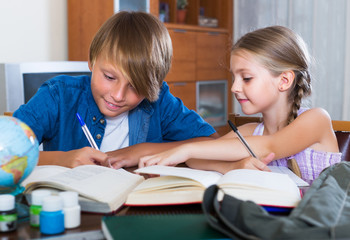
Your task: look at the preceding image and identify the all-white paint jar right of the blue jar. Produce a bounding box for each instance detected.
[59,191,80,229]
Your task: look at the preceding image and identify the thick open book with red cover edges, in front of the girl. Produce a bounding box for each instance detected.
[125,165,307,208]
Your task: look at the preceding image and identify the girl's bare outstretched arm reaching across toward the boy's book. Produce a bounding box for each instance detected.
[139,108,339,167]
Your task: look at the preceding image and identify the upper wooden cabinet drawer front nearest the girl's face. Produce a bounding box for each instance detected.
[196,32,230,81]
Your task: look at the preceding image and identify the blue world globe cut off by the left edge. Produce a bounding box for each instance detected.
[0,116,39,195]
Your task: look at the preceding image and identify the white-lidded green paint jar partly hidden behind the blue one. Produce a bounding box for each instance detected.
[29,189,51,227]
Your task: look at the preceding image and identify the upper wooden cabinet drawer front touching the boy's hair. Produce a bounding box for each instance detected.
[165,29,196,82]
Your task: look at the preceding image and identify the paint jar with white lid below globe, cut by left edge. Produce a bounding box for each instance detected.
[0,194,17,232]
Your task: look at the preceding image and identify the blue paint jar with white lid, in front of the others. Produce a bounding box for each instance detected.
[40,196,64,235]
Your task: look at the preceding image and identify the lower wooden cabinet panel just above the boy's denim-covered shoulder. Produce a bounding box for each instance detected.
[168,82,196,111]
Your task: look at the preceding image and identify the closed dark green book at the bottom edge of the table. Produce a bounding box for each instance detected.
[102,214,229,240]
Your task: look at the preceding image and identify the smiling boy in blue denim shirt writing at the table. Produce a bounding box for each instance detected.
[14,12,218,168]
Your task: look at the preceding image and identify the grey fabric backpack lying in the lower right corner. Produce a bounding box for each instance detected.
[202,162,350,240]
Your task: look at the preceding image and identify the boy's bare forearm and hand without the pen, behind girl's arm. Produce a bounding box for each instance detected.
[107,133,219,169]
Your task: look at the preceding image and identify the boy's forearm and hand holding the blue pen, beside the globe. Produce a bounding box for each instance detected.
[38,147,107,168]
